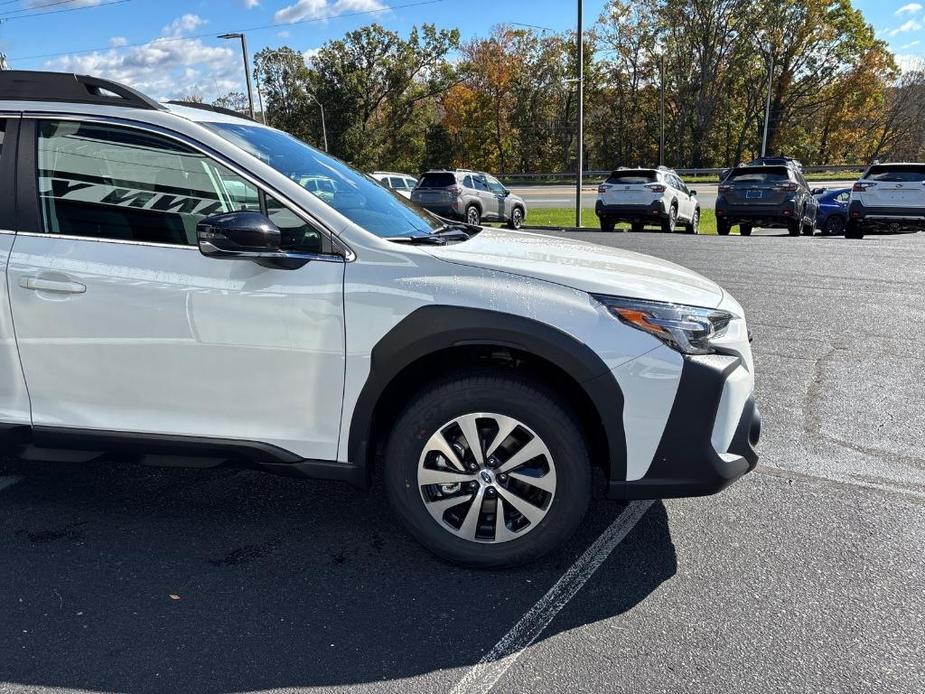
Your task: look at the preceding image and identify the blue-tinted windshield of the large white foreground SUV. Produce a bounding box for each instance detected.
[203,123,443,238]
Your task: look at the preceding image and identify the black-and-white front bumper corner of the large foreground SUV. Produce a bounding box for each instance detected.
[608,355,761,499]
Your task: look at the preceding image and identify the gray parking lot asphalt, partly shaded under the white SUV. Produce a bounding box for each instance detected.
[0,232,925,694]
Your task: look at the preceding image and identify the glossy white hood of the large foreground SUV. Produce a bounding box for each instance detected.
[427,228,723,308]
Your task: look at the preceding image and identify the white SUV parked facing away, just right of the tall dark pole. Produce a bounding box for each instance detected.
[594,166,700,234]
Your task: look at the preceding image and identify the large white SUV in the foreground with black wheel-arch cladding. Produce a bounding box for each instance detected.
[0,72,760,567]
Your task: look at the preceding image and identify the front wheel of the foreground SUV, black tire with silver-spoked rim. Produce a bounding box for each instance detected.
[384,371,591,569]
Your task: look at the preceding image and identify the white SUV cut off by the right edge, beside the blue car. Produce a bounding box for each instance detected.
[845,163,925,239]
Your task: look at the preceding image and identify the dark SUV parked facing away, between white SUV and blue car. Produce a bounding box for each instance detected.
[716,164,819,236]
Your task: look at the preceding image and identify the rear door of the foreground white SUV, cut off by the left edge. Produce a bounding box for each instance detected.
[0,114,31,428]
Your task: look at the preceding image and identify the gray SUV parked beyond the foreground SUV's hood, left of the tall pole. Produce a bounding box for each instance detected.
[411,169,527,229]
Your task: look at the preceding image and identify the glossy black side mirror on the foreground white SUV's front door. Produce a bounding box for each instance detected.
[196,210,308,270]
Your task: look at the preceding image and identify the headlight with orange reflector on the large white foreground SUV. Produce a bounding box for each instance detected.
[591,294,734,354]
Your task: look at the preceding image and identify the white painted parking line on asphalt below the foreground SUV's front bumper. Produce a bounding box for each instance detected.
[451,501,653,694]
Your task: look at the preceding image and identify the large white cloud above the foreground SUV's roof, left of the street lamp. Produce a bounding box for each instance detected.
[45,15,244,100]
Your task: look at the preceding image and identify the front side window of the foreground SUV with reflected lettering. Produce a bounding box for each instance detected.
[38,121,260,245]
